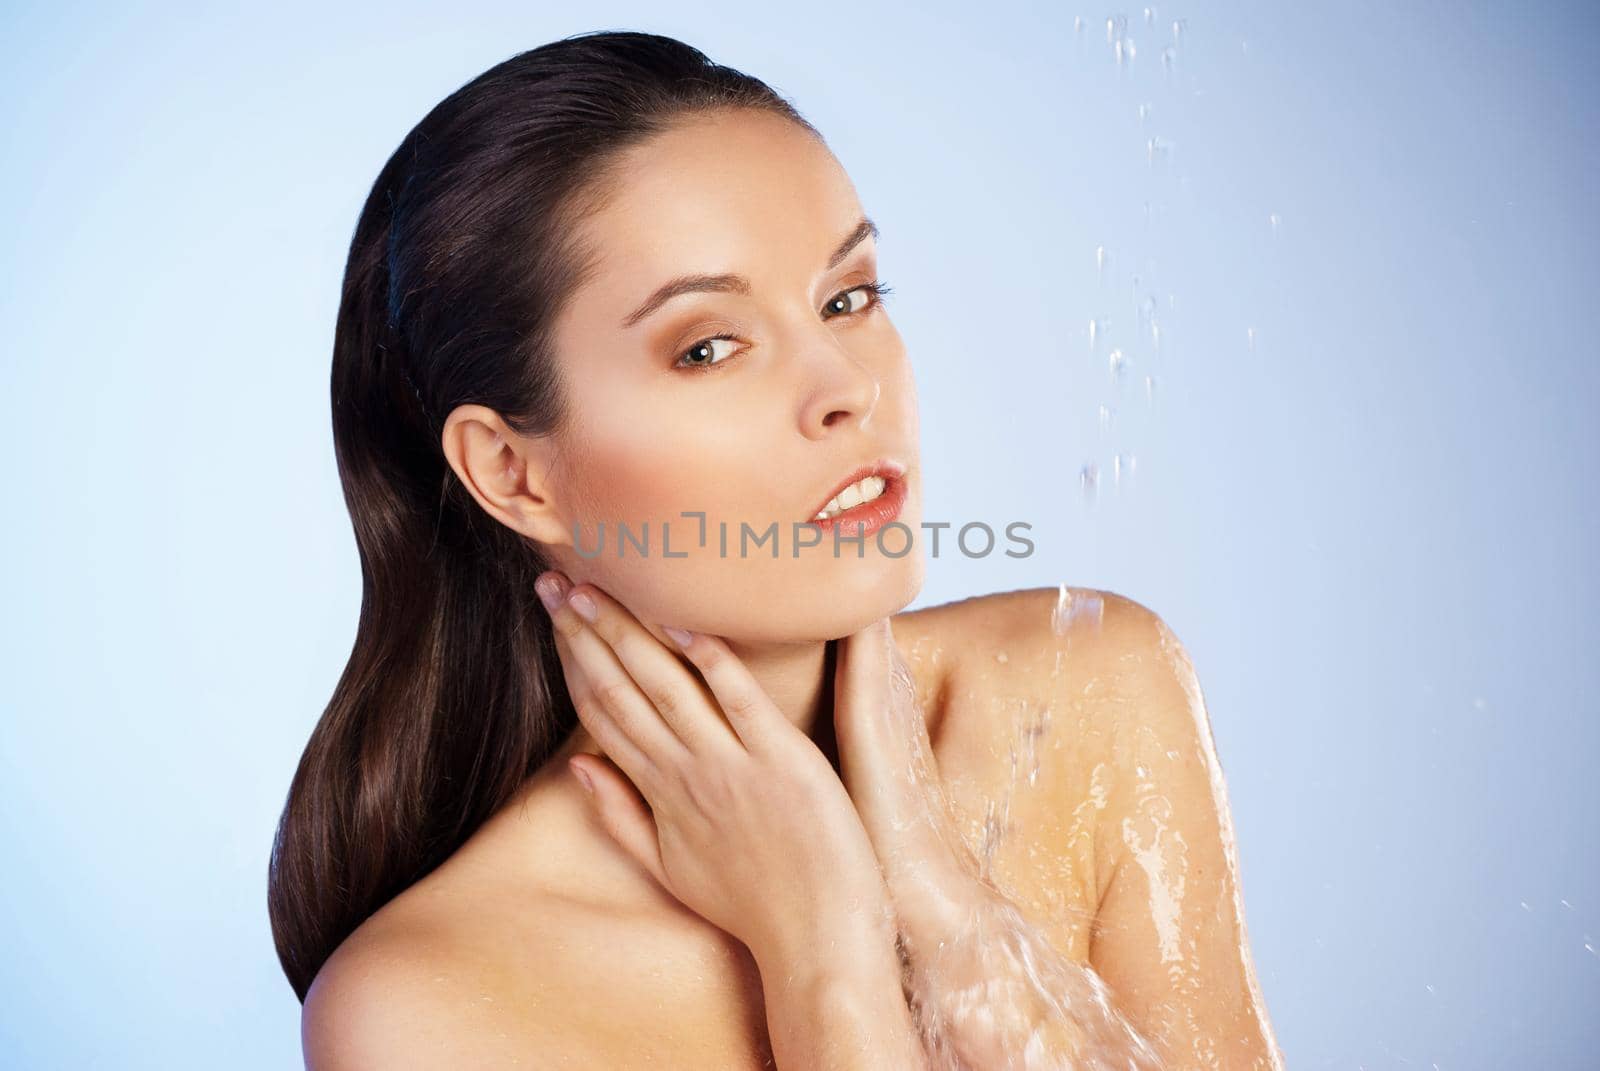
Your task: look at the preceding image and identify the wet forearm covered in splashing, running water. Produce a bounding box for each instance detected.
[899,879,1158,1071]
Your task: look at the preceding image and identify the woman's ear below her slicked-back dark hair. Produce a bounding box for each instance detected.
[440,405,573,544]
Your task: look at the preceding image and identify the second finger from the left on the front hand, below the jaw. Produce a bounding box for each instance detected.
[560,584,739,756]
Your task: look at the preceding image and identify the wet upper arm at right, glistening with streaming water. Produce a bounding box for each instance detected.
[1090,596,1282,1068]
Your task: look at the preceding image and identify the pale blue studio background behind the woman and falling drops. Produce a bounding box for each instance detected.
[0,2,1600,1069]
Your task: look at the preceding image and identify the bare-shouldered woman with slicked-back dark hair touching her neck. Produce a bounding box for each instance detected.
[269,32,1278,1069]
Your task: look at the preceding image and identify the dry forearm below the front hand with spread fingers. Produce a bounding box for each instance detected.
[754,914,928,1071]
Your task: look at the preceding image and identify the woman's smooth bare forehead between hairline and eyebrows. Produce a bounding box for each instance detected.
[582,109,862,296]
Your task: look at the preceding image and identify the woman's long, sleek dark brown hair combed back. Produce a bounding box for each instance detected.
[267,30,819,1001]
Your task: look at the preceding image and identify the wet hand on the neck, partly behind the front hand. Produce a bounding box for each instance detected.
[834,618,990,948]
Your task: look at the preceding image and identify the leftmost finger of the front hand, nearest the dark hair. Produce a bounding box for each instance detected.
[534,575,690,781]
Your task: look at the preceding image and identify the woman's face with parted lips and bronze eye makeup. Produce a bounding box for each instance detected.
[530,110,925,642]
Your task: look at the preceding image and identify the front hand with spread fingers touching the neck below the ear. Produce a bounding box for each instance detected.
[538,572,894,970]
